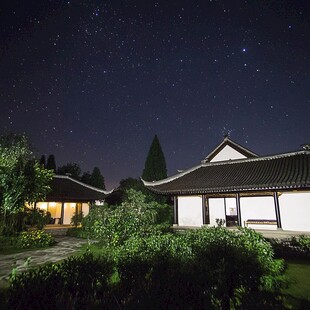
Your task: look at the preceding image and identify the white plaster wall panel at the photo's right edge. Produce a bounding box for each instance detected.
[279,192,310,231]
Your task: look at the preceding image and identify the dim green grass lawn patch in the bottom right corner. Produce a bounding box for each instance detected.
[284,260,310,309]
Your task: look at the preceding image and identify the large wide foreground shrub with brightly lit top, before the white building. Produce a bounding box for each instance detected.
[116,228,283,309]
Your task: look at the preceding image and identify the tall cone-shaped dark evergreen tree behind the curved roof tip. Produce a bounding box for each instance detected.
[142,135,167,181]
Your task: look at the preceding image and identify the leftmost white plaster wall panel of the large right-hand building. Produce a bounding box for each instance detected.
[178,196,203,226]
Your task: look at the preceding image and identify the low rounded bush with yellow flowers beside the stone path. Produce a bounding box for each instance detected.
[16,230,55,249]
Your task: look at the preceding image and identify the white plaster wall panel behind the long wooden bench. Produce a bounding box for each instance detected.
[240,196,277,230]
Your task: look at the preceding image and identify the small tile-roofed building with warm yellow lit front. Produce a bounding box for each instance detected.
[36,175,111,224]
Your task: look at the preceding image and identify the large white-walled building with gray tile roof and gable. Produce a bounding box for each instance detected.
[144,137,310,232]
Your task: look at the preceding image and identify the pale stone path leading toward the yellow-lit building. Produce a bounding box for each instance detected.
[0,236,87,286]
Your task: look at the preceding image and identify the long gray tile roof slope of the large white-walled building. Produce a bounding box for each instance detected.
[144,151,310,194]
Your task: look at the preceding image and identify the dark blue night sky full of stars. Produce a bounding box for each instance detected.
[0,0,310,189]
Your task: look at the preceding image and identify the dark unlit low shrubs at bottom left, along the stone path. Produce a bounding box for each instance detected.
[8,253,115,309]
